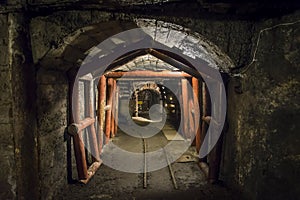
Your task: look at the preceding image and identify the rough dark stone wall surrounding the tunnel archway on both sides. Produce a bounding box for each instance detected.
[0,0,300,199]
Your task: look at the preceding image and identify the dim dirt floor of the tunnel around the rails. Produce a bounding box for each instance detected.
[56,121,240,200]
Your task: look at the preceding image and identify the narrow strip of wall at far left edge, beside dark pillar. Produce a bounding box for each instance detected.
[0,14,16,199]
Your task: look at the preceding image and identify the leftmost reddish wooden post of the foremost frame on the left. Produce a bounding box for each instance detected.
[72,82,88,179]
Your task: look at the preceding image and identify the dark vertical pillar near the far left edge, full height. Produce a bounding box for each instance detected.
[8,13,39,199]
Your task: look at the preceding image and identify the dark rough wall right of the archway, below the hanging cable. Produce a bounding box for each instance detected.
[222,14,300,199]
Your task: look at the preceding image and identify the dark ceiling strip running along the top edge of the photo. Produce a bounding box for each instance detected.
[0,0,300,19]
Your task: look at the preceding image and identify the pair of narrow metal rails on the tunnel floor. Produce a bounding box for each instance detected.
[142,138,178,190]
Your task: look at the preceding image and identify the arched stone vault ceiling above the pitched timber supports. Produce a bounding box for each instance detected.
[40,19,234,79]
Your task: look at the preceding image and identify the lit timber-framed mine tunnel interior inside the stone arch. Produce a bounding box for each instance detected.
[60,46,227,198]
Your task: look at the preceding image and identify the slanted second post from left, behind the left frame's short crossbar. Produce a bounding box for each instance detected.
[88,80,100,162]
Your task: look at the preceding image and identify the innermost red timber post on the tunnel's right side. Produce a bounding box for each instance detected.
[181,79,190,138]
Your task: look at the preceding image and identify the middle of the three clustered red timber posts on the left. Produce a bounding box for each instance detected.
[105,78,114,144]
